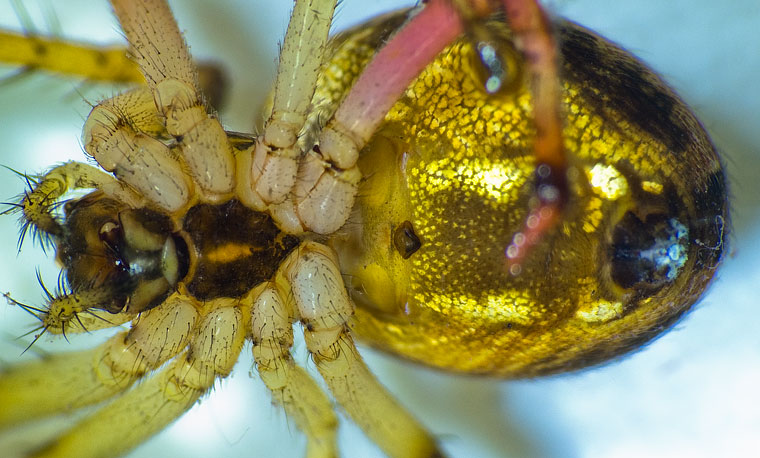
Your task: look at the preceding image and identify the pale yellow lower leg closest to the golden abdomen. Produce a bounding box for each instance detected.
[277,242,440,457]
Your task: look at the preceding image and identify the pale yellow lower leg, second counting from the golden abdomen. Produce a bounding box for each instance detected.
[251,284,338,458]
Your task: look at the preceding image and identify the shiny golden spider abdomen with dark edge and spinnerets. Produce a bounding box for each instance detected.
[324,13,728,377]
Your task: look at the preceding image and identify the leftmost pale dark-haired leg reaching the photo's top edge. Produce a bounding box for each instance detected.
[109,0,235,201]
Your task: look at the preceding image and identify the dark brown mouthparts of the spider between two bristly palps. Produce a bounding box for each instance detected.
[57,193,189,313]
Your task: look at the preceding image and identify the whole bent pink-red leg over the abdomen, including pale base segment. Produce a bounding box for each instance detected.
[295,0,568,268]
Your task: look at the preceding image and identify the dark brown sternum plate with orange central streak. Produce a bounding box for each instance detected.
[183,200,300,300]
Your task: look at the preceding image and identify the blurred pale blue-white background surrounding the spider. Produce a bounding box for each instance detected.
[0,0,760,458]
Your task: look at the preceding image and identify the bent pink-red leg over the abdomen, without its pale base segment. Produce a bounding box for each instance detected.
[320,0,568,275]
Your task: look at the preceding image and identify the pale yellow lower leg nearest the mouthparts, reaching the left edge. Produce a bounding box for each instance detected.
[0,296,198,430]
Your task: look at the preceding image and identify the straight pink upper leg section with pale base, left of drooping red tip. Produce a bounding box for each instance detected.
[285,0,462,234]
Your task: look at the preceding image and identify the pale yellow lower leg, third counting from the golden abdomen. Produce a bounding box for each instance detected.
[26,299,247,458]
